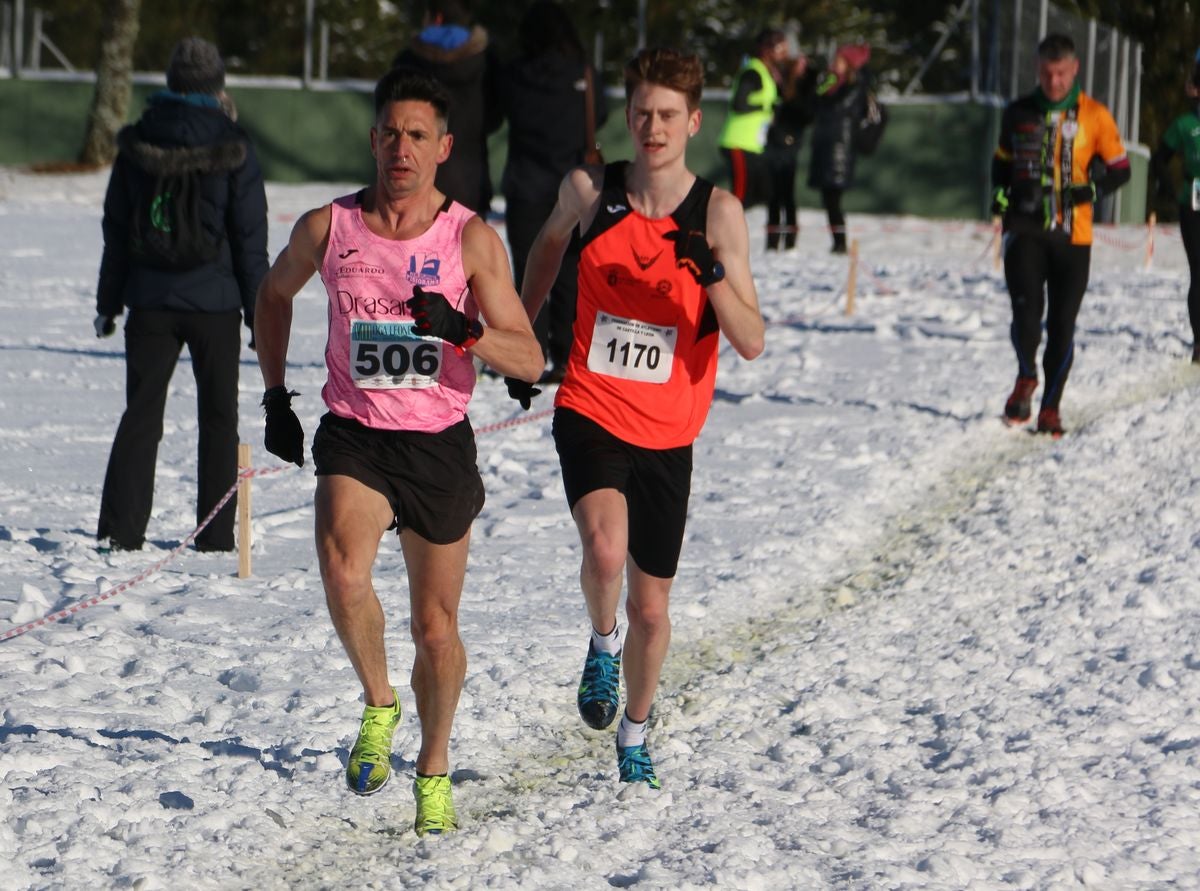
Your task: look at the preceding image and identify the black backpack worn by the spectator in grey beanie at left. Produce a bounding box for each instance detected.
[130,169,224,273]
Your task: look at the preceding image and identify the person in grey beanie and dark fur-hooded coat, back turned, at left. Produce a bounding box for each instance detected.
[95,37,268,550]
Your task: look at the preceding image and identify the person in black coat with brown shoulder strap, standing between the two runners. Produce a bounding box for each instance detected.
[499,0,607,381]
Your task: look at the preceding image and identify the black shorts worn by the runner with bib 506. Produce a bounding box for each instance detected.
[312,412,484,544]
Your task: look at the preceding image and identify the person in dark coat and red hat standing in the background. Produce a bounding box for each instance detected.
[809,43,871,253]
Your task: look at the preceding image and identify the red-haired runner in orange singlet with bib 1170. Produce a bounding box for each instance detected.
[509,49,763,789]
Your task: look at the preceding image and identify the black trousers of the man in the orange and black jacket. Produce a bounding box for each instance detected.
[1004,232,1092,408]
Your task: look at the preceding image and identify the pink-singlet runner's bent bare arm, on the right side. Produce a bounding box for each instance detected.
[462,216,545,383]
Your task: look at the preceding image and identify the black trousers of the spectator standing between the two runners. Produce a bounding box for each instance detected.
[504,198,581,369]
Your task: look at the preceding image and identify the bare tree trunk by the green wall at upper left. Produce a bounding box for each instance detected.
[79,0,142,166]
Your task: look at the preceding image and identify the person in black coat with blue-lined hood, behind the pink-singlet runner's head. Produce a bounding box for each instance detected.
[392,0,503,217]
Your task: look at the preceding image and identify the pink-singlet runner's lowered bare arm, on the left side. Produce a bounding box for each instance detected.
[254,211,331,390]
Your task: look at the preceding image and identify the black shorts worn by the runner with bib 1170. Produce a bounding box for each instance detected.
[553,408,691,579]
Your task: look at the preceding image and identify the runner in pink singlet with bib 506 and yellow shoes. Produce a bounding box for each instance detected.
[254,68,542,835]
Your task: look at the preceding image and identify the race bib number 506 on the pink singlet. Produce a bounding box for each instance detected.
[350,319,444,390]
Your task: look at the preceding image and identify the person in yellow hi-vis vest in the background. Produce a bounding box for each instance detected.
[718,29,788,208]
